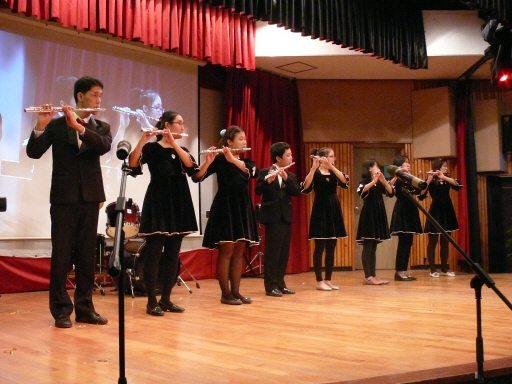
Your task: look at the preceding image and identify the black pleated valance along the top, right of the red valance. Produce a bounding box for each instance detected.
[204,0,427,69]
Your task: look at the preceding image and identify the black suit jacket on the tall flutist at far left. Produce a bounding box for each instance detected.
[27,117,112,204]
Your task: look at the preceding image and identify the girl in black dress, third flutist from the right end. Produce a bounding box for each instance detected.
[356,159,393,285]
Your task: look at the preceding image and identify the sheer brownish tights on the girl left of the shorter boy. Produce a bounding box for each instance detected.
[217,241,246,299]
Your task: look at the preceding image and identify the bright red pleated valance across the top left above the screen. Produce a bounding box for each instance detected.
[0,0,256,70]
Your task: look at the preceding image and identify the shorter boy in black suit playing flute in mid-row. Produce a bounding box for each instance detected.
[255,142,300,297]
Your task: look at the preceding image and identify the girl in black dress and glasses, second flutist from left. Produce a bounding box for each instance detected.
[130,111,214,316]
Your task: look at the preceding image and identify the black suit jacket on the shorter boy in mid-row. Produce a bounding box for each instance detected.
[255,168,300,224]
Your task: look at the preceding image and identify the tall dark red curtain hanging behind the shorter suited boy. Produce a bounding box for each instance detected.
[225,69,310,273]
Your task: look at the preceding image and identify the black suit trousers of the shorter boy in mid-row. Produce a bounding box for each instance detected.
[264,218,292,292]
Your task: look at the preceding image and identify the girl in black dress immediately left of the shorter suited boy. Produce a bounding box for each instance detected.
[198,126,259,305]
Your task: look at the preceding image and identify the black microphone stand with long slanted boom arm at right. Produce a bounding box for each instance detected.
[402,187,512,383]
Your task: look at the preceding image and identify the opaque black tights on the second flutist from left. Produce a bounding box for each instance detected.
[142,235,183,308]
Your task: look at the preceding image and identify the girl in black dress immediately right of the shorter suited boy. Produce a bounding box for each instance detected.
[301,147,349,291]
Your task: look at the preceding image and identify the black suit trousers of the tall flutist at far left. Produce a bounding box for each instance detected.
[50,203,99,318]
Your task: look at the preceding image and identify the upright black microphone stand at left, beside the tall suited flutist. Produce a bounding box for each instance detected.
[109,159,131,384]
